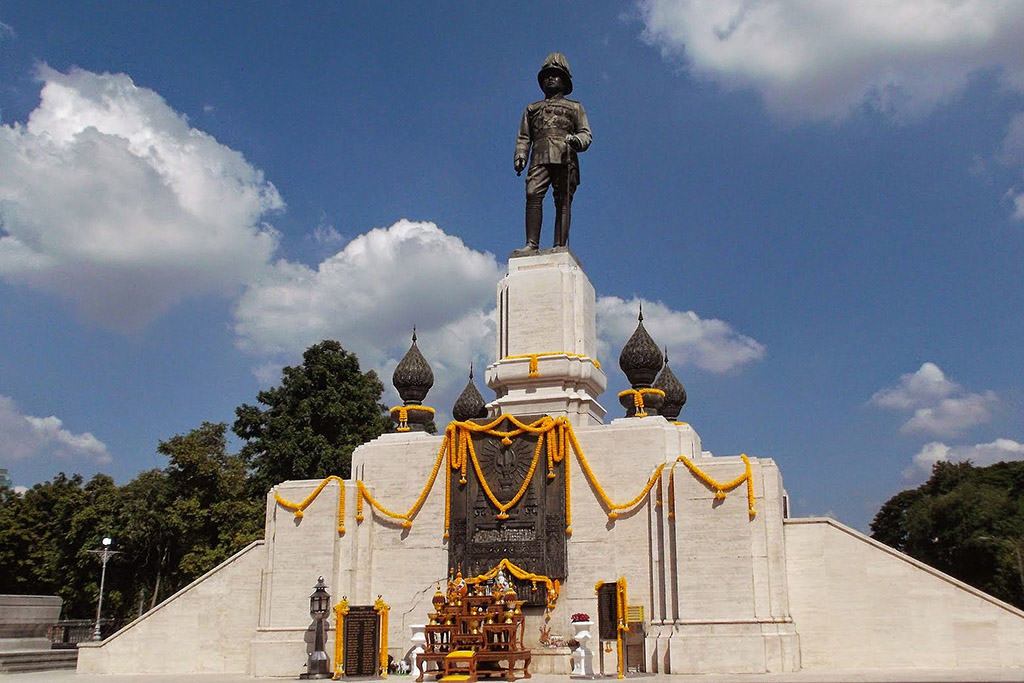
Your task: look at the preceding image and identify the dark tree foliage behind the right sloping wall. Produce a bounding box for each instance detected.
[871,462,1024,607]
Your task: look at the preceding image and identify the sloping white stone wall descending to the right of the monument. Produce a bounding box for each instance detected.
[784,519,1024,671]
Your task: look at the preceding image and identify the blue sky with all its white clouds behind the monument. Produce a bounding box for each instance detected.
[0,0,1024,528]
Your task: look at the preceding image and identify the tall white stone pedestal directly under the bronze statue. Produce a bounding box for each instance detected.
[486,250,608,425]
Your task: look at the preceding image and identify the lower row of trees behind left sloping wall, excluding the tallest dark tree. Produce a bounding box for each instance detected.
[0,423,264,623]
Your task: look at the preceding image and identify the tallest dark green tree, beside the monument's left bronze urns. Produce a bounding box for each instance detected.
[233,340,388,495]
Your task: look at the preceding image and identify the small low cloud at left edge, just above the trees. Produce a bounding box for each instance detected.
[0,395,111,463]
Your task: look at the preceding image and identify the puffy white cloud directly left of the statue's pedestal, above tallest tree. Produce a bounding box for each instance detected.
[234,220,503,417]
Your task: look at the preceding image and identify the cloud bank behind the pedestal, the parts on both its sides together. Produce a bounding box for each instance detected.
[234,220,765,419]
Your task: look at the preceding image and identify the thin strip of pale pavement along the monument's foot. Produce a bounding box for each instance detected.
[0,669,1024,683]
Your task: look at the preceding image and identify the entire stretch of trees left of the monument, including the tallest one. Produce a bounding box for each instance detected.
[0,341,397,624]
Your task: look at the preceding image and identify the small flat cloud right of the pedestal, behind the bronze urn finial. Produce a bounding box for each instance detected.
[597,296,765,373]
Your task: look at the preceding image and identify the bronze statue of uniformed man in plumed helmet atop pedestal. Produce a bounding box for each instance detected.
[513,52,593,254]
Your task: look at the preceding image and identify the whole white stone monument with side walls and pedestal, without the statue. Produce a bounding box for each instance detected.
[79,246,1024,680]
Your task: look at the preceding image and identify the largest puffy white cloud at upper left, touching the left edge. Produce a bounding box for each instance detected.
[0,67,284,330]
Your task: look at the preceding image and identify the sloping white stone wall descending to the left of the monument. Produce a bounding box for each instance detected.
[78,541,266,674]
